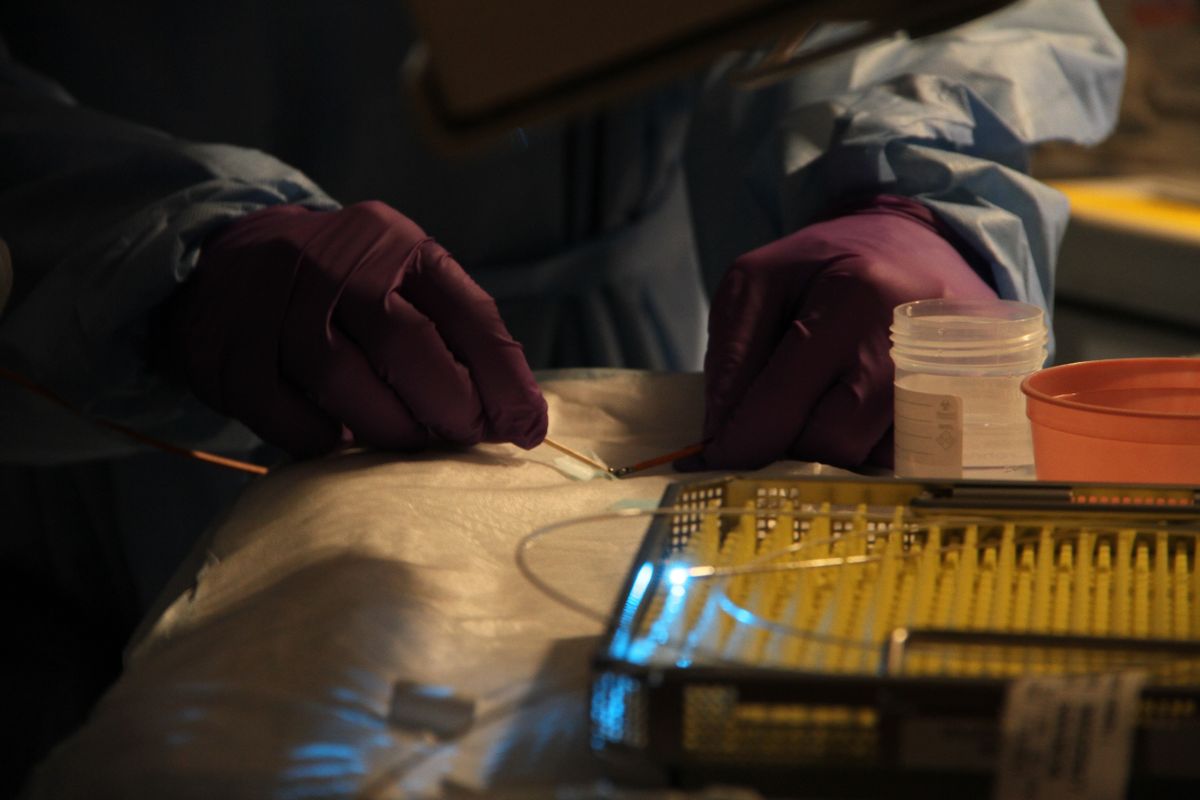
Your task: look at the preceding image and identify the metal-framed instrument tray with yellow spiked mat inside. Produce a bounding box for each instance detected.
[590,477,1200,794]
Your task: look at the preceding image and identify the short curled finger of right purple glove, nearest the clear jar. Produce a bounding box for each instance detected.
[788,381,893,467]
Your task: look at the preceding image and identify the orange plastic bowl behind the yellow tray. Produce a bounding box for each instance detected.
[1021,359,1200,483]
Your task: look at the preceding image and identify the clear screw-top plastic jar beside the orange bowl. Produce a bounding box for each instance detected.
[892,300,1046,479]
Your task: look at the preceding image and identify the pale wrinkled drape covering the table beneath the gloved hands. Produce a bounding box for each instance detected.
[26,371,811,800]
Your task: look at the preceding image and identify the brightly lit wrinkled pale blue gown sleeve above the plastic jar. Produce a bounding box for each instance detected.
[729,0,1124,347]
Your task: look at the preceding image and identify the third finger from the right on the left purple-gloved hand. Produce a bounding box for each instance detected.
[284,326,430,450]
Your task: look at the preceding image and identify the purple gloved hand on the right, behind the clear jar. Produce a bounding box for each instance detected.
[679,196,996,469]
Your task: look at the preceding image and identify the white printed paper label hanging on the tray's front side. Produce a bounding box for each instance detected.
[994,673,1146,800]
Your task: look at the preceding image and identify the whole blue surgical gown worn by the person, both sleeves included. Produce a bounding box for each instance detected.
[0,0,1123,606]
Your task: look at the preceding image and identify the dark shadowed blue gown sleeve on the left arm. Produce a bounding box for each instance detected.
[0,70,335,462]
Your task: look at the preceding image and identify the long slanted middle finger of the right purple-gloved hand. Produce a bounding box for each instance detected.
[703,320,839,469]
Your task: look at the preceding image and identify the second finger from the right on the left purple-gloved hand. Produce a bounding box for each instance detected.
[335,290,484,444]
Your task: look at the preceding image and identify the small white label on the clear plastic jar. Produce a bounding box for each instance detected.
[895,385,962,477]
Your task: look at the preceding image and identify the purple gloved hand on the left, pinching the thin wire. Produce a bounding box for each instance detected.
[167,203,546,456]
